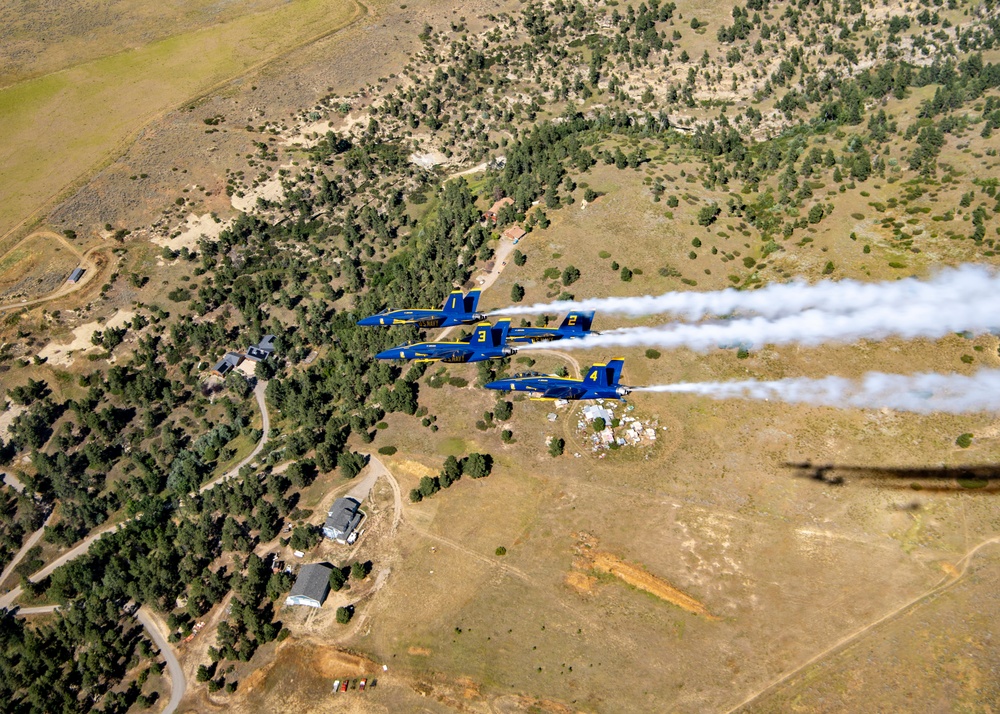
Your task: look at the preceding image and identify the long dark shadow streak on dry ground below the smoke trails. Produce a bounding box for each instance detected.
[783,461,1000,494]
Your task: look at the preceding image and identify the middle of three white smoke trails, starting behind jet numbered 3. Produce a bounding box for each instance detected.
[520,296,1000,351]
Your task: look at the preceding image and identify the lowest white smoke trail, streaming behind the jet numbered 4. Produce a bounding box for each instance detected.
[632,369,1000,414]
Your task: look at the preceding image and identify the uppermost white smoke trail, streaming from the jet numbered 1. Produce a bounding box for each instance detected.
[490,264,1000,320]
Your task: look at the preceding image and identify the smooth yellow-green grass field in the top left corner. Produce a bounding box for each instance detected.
[0,0,365,245]
